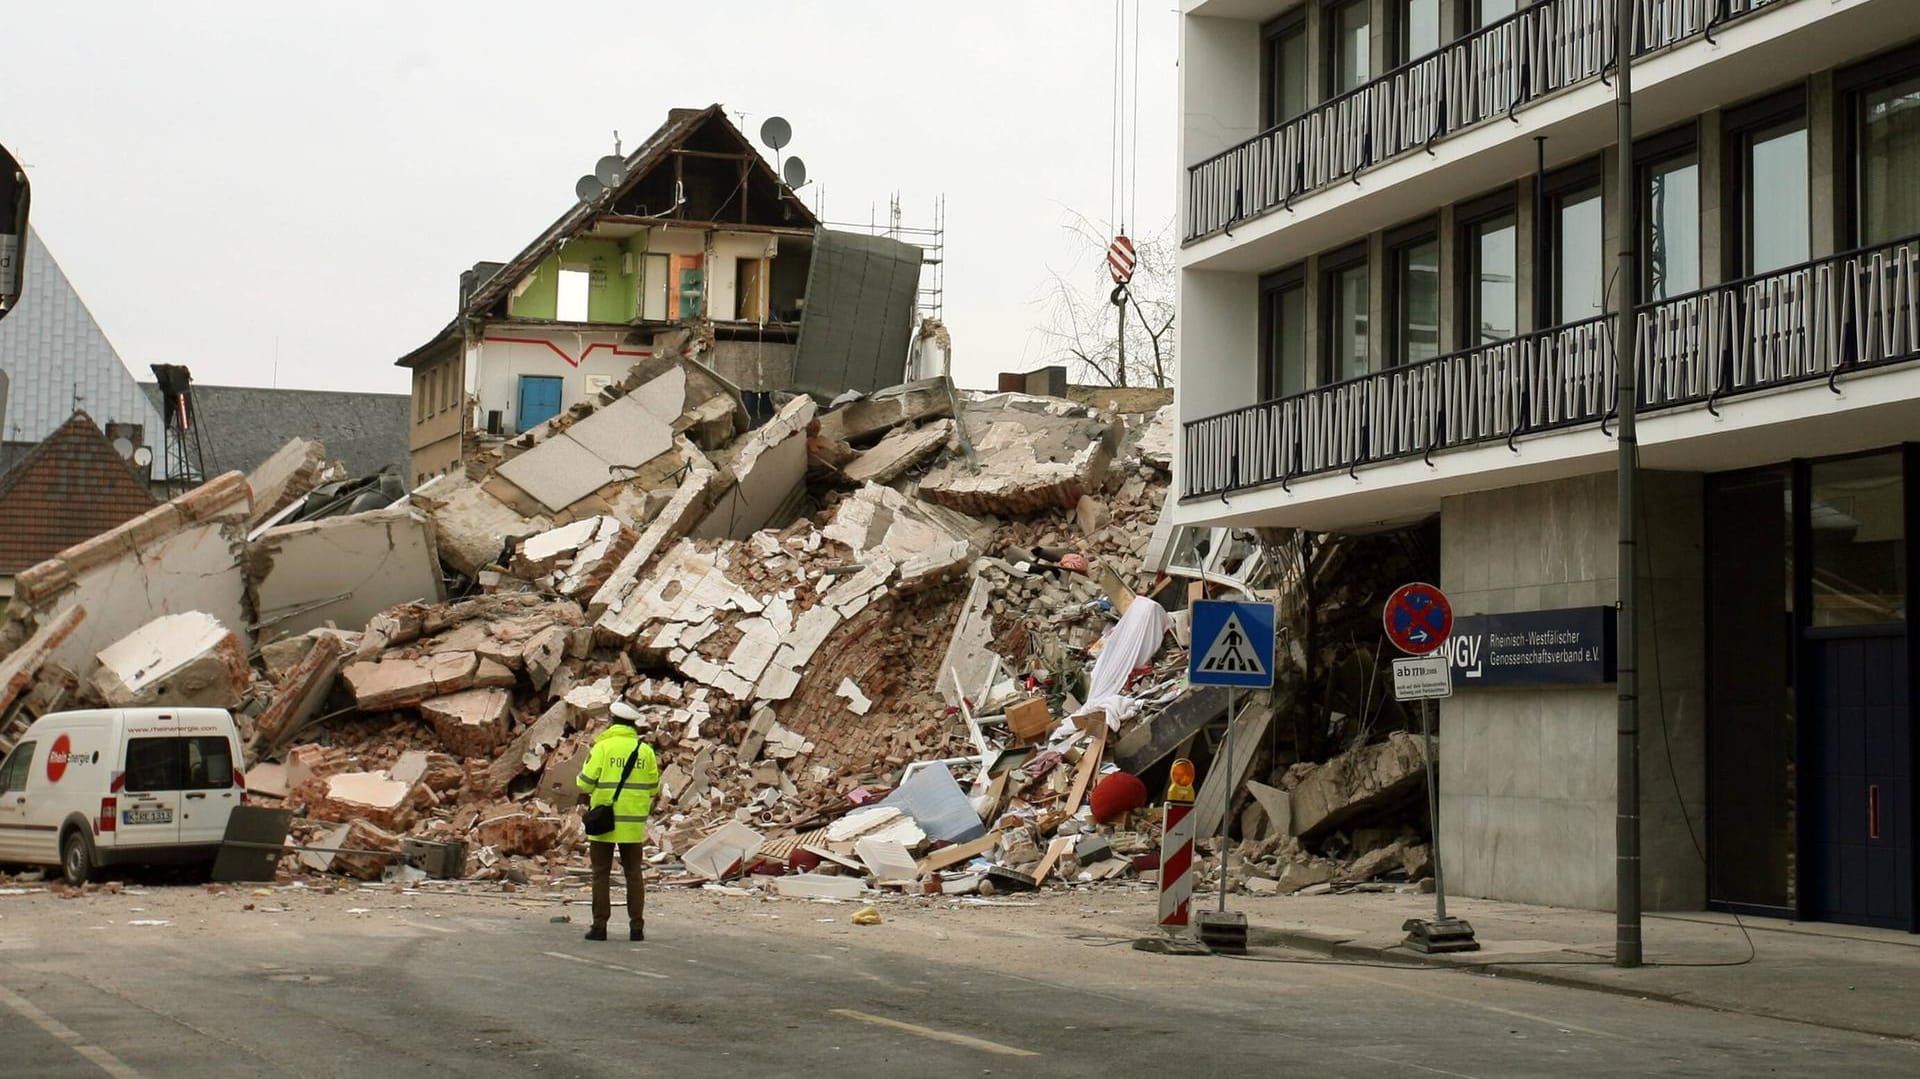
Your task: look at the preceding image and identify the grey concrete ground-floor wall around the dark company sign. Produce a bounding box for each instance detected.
[1438,472,1707,910]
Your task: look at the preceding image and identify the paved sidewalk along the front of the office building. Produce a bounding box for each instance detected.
[1228,895,1920,1039]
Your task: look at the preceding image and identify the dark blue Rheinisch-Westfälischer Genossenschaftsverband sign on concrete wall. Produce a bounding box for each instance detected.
[1440,607,1617,689]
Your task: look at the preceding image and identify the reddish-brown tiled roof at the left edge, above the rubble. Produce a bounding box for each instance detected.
[0,413,159,574]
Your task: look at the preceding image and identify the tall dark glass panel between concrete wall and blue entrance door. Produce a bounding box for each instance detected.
[1707,467,1797,910]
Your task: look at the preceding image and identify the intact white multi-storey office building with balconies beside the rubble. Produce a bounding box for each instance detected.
[1164,0,1920,929]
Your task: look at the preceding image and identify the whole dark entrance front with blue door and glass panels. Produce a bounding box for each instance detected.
[1707,449,1920,929]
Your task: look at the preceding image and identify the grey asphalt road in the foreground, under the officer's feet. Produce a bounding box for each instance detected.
[0,889,1920,1079]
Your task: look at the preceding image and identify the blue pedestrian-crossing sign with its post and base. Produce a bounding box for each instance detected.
[1187,599,1275,952]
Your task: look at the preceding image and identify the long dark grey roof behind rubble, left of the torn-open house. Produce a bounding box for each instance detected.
[140,382,411,476]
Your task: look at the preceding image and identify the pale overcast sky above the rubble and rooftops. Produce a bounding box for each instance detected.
[0,0,1177,392]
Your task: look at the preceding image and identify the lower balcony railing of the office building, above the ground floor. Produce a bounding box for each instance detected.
[1181,236,1920,497]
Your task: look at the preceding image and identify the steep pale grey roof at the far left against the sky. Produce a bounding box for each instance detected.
[0,228,161,445]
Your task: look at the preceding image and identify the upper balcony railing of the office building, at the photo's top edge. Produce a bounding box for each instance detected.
[1187,0,1788,240]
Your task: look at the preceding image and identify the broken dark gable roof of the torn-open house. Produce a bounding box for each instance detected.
[394,104,820,367]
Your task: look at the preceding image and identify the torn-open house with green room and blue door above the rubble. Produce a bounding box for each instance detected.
[397,106,922,482]
